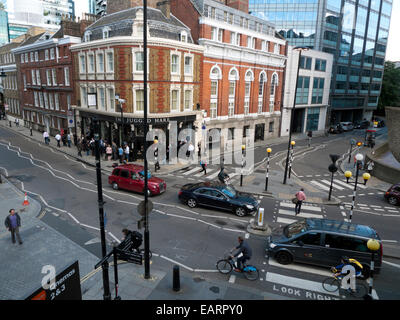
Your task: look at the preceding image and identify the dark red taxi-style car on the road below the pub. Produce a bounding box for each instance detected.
[108,164,167,196]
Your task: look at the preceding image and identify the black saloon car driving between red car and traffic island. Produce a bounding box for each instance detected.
[178,181,259,217]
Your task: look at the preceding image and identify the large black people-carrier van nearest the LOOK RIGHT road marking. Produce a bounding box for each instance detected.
[266,218,383,277]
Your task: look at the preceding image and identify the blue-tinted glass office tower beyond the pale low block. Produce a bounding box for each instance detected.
[249,0,392,123]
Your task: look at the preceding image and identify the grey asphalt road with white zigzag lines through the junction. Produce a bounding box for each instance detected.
[0,124,400,299]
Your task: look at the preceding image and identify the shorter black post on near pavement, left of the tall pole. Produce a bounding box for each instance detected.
[94,120,111,300]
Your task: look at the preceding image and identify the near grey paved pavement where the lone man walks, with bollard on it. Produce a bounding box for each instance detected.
[0,177,288,300]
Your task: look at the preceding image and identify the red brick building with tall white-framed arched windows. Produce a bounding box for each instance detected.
[170,0,287,143]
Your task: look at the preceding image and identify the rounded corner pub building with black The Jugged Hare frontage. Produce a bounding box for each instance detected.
[71,5,203,159]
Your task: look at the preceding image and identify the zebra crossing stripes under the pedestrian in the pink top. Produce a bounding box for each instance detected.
[274,200,326,224]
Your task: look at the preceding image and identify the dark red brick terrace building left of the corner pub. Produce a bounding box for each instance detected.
[13,18,94,135]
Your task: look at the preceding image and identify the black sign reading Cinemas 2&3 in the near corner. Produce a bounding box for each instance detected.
[25,261,82,300]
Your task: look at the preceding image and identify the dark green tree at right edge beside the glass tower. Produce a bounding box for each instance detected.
[377,61,400,113]
